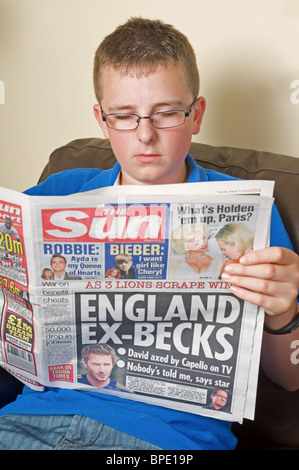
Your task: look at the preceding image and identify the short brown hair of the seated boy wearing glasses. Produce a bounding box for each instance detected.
[93,17,199,103]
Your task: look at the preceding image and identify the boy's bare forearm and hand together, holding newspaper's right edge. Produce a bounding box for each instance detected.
[222,247,299,391]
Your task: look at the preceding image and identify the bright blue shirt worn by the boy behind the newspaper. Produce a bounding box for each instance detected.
[0,155,292,450]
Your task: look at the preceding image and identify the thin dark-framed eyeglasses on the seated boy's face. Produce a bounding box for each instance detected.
[101,98,197,131]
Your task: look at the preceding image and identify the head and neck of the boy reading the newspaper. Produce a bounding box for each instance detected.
[94,18,205,184]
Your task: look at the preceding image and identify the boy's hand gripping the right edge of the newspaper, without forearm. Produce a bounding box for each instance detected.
[222,247,299,329]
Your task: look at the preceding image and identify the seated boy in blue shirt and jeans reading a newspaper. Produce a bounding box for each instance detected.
[0,19,299,450]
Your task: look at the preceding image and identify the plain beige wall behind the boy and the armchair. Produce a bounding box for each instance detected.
[0,0,299,191]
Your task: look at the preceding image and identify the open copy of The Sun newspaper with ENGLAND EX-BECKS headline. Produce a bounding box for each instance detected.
[0,181,274,421]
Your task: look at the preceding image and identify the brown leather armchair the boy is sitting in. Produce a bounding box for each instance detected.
[0,138,299,450]
